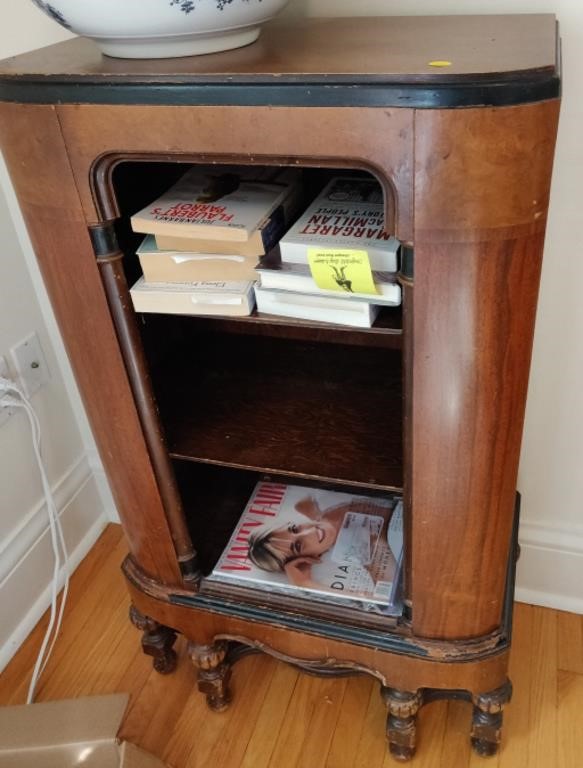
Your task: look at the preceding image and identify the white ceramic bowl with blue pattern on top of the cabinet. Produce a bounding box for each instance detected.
[33,0,289,59]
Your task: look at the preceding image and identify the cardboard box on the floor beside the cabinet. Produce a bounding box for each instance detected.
[0,693,165,768]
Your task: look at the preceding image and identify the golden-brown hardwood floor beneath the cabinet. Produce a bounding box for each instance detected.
[0,525,583,768]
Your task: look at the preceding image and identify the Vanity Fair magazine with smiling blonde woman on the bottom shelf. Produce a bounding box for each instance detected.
[207,481,403,615]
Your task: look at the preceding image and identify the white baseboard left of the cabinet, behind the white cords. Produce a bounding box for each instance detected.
[0,456,109,671]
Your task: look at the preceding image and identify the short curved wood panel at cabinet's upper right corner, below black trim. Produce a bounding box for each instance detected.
[415,100,559,240]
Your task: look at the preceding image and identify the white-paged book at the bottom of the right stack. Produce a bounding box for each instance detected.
[255,285,380,328]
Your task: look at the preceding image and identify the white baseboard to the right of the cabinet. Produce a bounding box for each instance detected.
[515,520,583,614]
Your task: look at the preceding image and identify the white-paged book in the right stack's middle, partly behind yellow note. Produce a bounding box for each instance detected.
[255,251,401,307]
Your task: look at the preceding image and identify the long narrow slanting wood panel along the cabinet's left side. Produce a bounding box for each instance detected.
[0,104,180,584]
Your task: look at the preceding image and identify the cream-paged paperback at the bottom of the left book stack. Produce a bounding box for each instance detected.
[130,277,255,317]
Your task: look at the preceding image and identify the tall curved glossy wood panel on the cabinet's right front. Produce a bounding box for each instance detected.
[411,236,542,638]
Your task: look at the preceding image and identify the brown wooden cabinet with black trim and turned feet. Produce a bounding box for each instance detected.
[0,15,560,758]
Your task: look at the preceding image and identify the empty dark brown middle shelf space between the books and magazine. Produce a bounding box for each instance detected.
[154,334,403,490]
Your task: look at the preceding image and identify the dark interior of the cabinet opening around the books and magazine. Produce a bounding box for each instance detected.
[105,162,407,627]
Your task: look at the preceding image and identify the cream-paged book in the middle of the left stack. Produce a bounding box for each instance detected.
[136,235,257,283]
